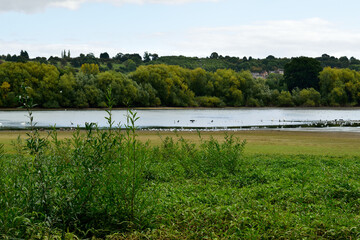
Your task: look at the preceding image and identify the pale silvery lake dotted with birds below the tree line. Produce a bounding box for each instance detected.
[0,108,360,131]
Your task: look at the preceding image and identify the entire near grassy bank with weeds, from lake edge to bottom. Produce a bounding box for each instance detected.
[0,125,360,239]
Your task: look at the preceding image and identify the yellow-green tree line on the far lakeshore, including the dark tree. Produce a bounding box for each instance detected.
[0,57,360,108]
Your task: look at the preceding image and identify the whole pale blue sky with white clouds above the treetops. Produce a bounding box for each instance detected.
[0,0,360,59]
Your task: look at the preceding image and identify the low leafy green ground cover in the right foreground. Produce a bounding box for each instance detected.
[145,155,360,239]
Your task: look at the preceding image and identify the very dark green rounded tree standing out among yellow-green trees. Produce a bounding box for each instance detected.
[284,57,322,91]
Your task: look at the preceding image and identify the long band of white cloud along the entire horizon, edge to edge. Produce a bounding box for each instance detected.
[0,18,360,58]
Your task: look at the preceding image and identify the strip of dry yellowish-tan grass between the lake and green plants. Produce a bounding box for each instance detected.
[0,130,360,156]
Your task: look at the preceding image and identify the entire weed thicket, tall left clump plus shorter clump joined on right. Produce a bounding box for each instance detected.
[0,94,245,239]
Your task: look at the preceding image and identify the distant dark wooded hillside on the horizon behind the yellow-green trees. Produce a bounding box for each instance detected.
[0,50,360,73]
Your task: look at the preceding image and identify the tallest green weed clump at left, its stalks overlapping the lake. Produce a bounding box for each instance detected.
[0,92,156,239]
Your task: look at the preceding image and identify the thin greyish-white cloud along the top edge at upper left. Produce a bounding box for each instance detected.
[0,0,219,13]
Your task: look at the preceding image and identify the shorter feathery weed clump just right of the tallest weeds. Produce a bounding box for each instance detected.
[153,135,246,180]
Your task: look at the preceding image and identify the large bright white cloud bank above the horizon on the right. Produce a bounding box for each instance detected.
[177,18,360,57]
